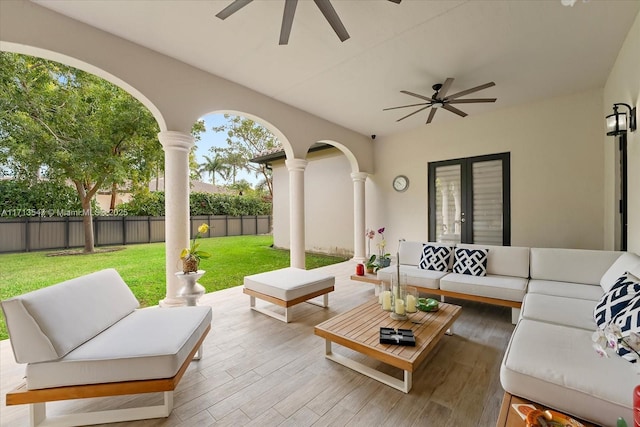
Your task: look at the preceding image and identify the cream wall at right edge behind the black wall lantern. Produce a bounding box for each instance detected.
[602,10,640,253]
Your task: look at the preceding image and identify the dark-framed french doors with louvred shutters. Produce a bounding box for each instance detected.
[428,153,511,246]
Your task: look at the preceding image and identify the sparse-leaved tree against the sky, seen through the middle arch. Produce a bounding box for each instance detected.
[212,114,282,196]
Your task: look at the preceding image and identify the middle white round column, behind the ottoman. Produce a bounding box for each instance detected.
[285,159,309,269]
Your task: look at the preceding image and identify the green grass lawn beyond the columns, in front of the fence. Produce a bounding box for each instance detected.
[0,236,345,340]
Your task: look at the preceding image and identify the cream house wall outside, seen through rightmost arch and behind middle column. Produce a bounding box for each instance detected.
[272,148,353,256]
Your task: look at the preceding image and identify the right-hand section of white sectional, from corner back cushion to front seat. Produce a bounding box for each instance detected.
[500,248,640,426]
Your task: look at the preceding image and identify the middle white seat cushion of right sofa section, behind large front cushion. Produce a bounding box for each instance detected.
[520,292,597,332]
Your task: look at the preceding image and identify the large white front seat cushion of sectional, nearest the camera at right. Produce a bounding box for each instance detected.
[500,319,638,426]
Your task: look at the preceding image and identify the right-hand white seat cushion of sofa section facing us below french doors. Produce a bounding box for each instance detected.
[440,273,527,301]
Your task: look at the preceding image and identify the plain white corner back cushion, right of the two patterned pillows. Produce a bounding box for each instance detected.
[531,248,622,285]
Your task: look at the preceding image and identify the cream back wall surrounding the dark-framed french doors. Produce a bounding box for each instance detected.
[372,90,604,249]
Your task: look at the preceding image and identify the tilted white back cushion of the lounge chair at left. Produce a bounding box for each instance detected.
[2,269,139,363]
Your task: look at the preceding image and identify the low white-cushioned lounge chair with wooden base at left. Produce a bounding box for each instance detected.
[2,269,211,426]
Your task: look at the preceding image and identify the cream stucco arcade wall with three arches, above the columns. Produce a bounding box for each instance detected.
[0,1,373,172]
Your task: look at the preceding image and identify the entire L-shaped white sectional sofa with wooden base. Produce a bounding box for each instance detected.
[378,242,640,426]
